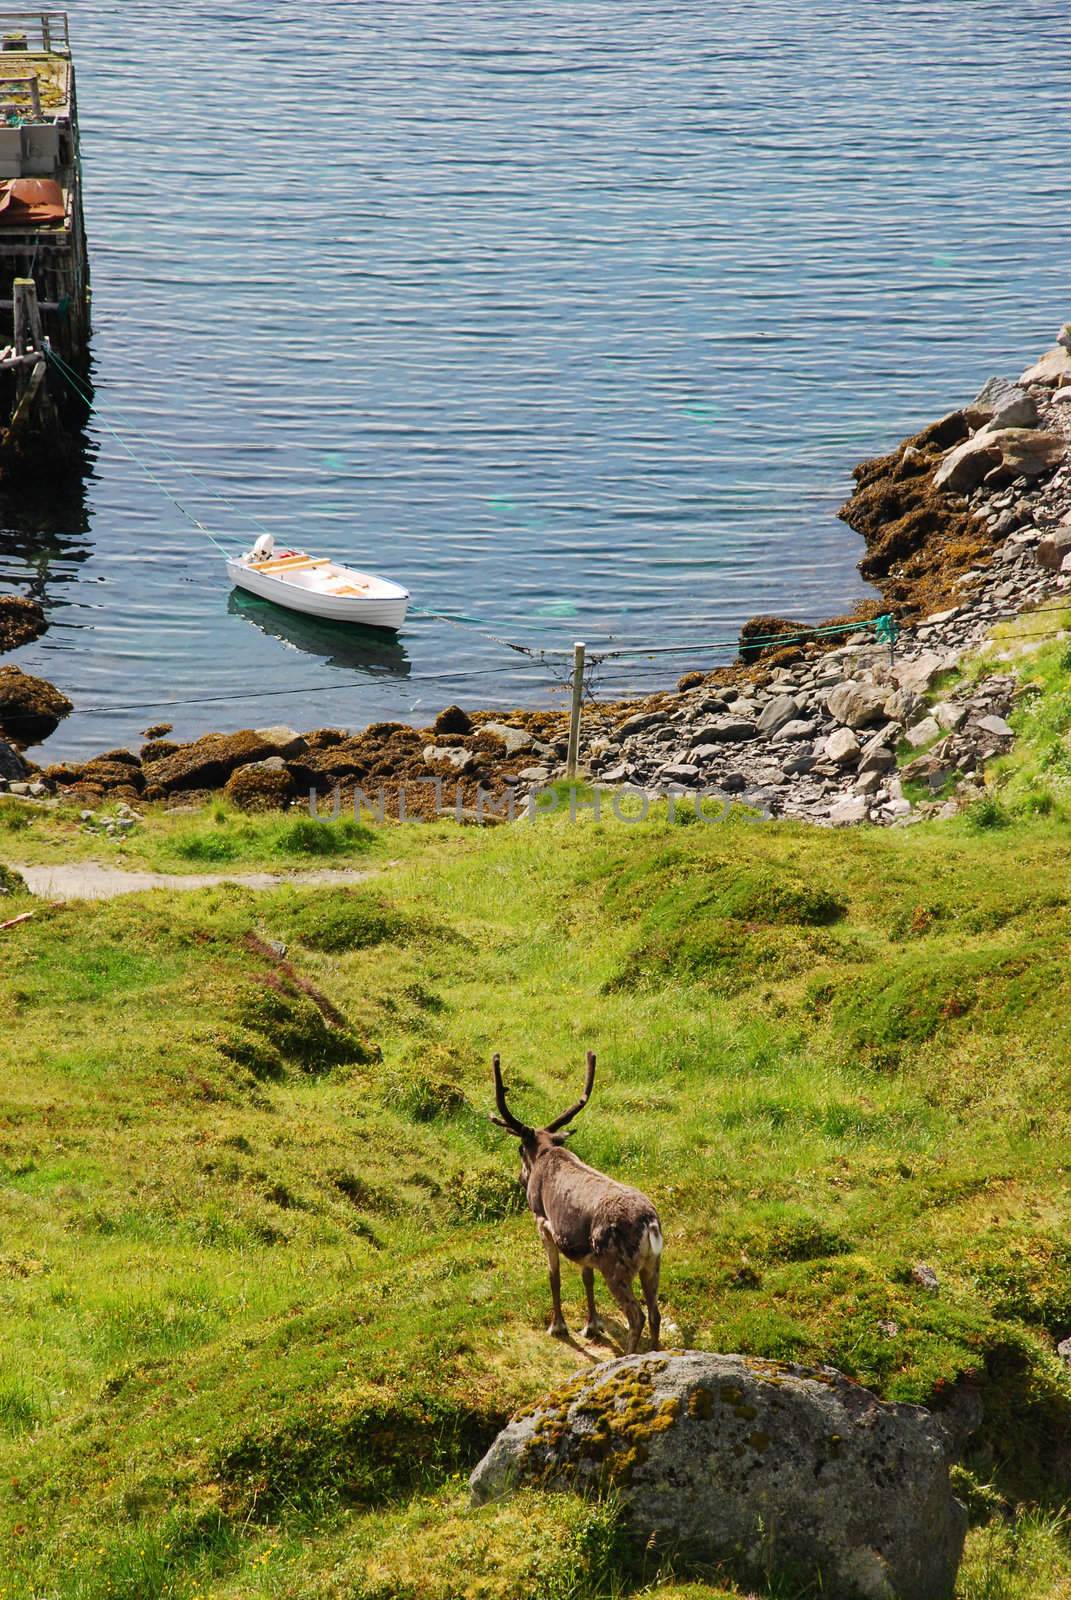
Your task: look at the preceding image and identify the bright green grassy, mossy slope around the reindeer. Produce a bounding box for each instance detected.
[0,630,1071,1600]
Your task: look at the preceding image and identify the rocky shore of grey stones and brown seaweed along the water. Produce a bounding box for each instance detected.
[0,330,1071,826]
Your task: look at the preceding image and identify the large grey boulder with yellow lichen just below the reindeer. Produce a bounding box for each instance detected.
[469,1350,967,1600]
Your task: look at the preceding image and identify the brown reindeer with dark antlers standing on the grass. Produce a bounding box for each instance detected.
[491,1050,661,1355]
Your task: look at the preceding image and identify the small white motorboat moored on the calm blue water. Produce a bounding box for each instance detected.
[227,534,410,632]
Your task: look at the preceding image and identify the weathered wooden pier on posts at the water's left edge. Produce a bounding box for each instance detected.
[0,11,90,474]
